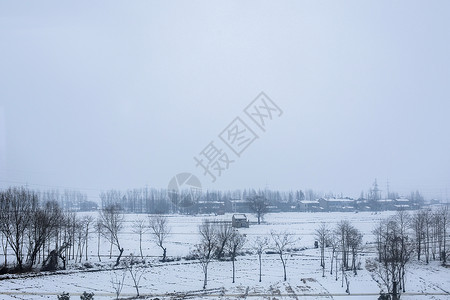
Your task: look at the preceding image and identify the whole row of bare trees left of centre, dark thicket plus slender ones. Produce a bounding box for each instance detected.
[0,187,170,272]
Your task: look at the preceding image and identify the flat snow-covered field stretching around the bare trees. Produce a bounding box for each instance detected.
[0,212,450,299]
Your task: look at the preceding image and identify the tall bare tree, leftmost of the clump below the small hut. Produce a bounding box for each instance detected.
[195,220,217,289]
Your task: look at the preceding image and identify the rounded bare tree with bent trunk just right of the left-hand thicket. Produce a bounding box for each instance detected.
[100,205,124,266]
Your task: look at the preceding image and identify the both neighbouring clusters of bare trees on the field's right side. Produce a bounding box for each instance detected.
[315,206,449,299]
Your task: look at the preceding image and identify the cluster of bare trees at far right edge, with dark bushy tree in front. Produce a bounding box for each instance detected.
[373,206,449,299]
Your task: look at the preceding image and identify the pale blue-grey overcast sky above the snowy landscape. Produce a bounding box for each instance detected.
[0,1,450,202]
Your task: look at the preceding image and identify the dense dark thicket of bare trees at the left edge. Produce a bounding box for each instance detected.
[0,188,104,272]
